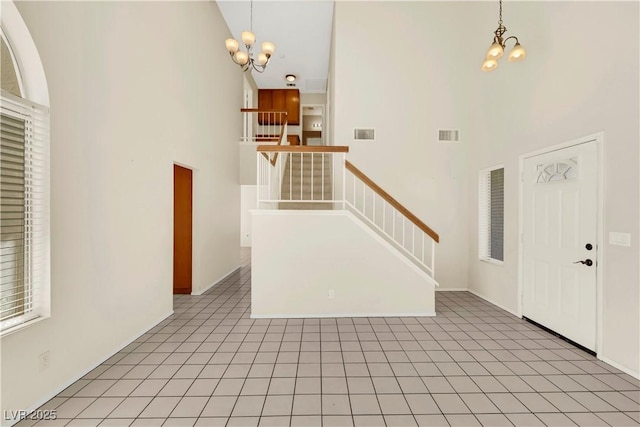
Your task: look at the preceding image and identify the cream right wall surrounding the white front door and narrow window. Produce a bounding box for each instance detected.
[467,2,640,376]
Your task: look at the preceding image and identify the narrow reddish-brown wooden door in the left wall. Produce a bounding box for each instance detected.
[173,165,193,294]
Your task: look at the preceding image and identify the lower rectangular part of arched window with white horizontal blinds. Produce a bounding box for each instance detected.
[0,91,49,334]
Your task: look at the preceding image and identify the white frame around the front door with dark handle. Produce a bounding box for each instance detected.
[517,131,605,359]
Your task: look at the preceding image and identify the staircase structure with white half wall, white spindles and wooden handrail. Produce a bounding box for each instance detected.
[251,136,439,318]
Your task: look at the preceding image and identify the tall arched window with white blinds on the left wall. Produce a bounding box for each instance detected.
[0,2,50,335]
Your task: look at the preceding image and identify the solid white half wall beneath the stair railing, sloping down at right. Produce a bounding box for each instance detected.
[251,210,435,317]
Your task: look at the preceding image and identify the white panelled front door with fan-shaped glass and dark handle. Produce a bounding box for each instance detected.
[522,141,598,351]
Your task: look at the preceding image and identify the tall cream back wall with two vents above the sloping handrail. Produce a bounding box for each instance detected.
[328,2,471,289]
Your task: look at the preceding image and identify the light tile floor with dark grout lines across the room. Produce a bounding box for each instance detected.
[18,253,640,427]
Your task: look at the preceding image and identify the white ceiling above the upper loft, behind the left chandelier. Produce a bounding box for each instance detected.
[216,0,333,93]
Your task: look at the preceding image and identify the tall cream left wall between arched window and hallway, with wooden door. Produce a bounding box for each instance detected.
[1,2,242,420]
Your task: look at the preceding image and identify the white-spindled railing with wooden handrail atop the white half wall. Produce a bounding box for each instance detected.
[257,145,440,284]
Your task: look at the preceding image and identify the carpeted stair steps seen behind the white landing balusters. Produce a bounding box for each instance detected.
[278,153,334,210]
